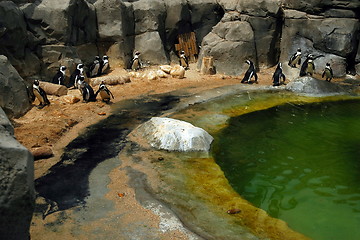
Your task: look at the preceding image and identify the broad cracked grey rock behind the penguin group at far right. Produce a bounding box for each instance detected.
[280,10,360,77]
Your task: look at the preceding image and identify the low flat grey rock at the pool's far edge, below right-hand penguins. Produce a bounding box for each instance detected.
[285,77,345,96]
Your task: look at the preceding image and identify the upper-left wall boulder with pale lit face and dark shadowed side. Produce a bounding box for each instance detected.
[22,0,97,45]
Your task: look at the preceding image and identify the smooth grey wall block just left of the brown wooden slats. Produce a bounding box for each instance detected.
[135,32,169,64]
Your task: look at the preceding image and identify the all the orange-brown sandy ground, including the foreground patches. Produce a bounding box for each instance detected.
[13,64,356,239]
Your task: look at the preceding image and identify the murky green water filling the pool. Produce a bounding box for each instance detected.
[213,101,360,240]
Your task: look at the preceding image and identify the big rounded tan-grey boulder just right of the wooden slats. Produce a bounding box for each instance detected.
[199,21,256,75]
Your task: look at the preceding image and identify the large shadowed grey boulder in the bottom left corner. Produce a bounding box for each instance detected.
[0,108,35,240]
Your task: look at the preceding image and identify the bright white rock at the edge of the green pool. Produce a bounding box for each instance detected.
[137,117,214,152]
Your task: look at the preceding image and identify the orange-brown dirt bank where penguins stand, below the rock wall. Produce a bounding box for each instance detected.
[13,64,274,175]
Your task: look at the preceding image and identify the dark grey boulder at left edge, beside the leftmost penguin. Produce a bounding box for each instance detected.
[0,55,31,117]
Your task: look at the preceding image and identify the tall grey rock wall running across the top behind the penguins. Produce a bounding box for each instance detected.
[0,0,360,81]
